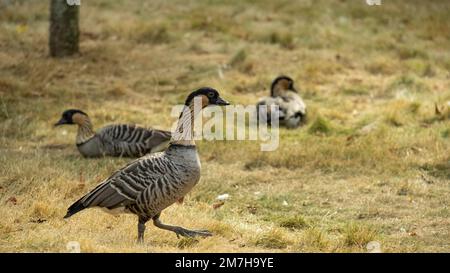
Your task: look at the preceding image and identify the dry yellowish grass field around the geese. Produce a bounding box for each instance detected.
[0,0,450,252]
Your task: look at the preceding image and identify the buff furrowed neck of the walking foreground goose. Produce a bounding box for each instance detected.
[170,96,204,146]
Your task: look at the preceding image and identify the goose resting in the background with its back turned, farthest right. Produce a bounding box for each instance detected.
[256,76,306,129]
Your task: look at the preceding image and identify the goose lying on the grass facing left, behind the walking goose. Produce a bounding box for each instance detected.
[55,109,171,157]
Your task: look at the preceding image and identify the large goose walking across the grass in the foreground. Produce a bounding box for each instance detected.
[64,87,229,242]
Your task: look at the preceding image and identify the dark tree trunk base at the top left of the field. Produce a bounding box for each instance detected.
[49,0,80,57]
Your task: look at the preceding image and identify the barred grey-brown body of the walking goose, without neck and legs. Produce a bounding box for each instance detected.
[65,145,200,219]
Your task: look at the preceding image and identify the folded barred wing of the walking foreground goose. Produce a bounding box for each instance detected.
[64,153,173,218]
